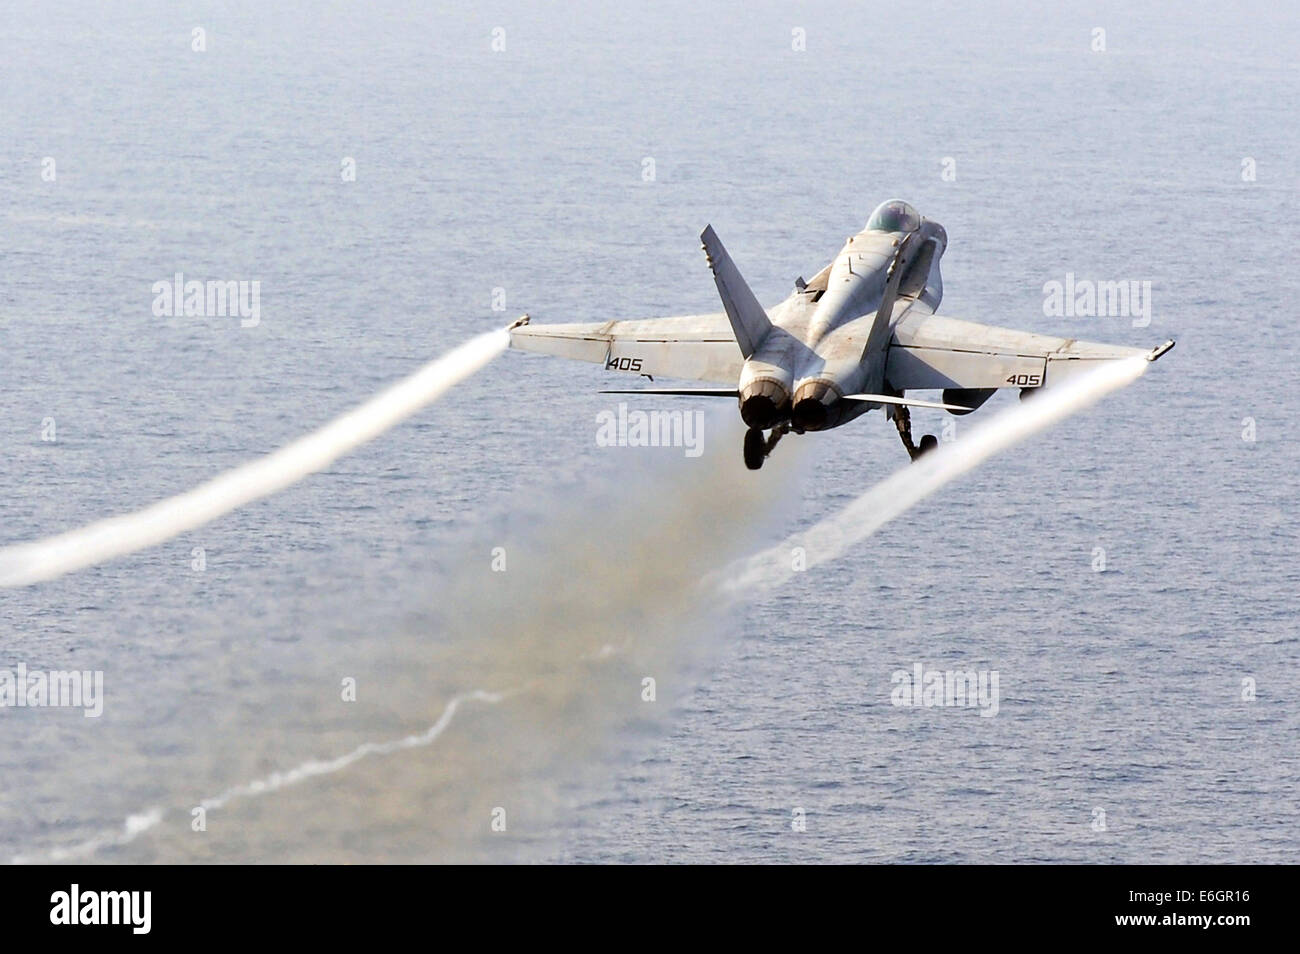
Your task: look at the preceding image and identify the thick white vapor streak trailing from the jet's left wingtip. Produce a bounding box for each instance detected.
[0,330,510,586]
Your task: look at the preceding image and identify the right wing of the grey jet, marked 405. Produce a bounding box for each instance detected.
[885,312,1174,391]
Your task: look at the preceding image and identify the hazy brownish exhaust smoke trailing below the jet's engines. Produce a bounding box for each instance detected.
[16,412,798,863]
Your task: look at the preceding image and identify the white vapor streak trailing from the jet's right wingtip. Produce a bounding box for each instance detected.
[716,357,1148,599]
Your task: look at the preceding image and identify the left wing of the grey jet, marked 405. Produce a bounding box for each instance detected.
[510,312,745,387]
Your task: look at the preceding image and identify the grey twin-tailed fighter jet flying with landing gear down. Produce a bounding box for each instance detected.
[511,199,1174,471]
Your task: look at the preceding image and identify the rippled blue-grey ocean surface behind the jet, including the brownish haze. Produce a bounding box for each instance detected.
[0,3,1300,863]
